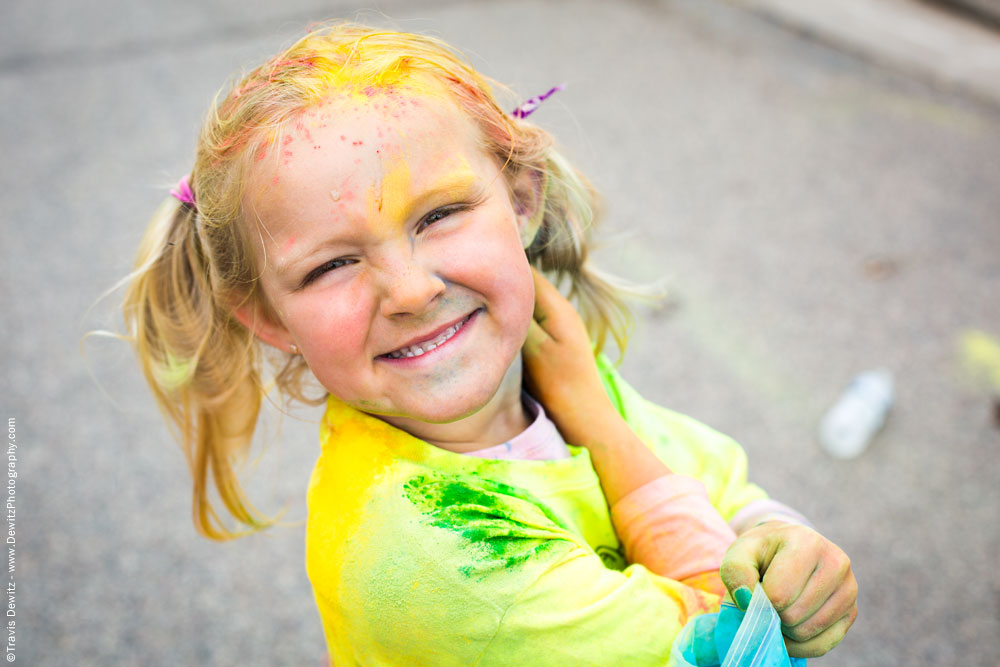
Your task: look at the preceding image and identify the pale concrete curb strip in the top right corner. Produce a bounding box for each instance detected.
[729,0,1000,106]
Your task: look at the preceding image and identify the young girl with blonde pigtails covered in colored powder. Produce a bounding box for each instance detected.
[125,20,857,665]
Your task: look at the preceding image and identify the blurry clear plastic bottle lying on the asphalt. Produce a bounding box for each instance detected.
[819,368,894,459]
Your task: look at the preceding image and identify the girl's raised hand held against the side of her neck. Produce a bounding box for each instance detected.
[522,267,617,428]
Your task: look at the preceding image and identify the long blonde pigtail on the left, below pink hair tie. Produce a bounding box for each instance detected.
[124,190,273,540]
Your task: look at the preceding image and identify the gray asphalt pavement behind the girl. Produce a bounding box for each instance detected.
[0,0,1000,667]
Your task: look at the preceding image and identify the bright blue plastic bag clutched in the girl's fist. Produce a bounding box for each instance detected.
[669,584,806,667]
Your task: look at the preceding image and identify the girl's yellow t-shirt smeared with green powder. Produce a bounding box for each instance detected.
[306,357,766,667]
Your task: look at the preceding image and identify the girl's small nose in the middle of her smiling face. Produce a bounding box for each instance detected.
[377,244,445,318]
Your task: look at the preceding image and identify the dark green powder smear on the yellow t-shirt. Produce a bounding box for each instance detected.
[403,475,566,577]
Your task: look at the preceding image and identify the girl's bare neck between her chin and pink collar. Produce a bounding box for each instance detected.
[376,355,531,454]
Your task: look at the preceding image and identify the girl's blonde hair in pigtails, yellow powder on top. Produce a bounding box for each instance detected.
[124,23,631,539]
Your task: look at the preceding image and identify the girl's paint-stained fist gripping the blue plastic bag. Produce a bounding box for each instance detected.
[721,521,858,658]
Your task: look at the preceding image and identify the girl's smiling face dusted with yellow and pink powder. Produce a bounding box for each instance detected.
[247,89,534,424]
